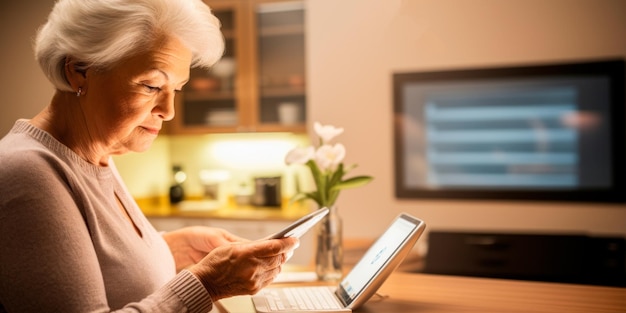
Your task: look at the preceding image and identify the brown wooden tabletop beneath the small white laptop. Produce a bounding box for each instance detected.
[213,272,626,313]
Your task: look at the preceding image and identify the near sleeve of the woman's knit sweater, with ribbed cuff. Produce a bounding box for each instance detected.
[0,143,212,313]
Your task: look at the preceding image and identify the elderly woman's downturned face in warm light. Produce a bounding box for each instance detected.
[80,38,192,155]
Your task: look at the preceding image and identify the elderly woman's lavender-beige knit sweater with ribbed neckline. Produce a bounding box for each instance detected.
[0,120,212,313]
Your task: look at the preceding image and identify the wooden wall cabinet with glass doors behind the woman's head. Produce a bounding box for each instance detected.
[168,0,306,134]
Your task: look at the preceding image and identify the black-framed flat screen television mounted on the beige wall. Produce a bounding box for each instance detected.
[393,60,626,202]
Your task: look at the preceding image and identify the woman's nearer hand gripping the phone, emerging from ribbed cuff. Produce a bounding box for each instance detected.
[189,238,299,301]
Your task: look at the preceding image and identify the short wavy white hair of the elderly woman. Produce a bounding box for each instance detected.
[34,0,224,91]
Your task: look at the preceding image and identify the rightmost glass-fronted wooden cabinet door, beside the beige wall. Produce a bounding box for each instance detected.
[250,0,306,131]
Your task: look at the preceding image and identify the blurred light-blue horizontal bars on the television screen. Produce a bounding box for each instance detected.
[424,86,580,188]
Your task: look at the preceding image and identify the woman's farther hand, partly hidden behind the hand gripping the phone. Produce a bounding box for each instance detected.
[163,226,248,272]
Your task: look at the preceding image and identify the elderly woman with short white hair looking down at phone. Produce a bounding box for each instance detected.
[0,0,298,312]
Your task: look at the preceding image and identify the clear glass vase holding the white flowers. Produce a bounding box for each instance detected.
[315,206,343,281]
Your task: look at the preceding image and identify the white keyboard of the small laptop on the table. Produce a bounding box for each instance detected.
[260,286,342,312]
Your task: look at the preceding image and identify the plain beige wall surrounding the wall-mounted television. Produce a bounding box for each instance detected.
[307,0,626,236]
